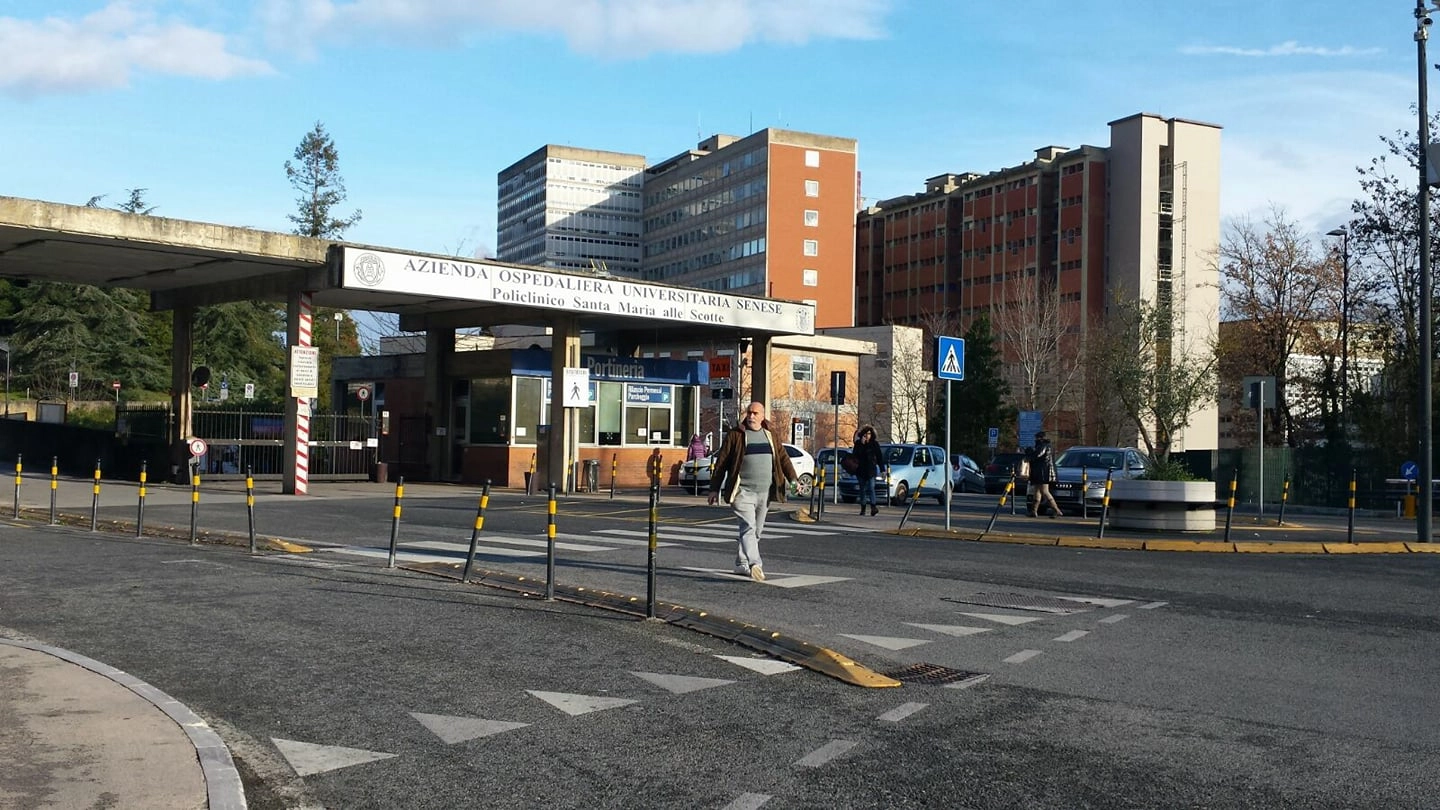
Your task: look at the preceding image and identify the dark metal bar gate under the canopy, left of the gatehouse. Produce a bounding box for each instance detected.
[115,404,377,481]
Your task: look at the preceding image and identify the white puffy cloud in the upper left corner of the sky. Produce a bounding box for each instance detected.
[0,0,272,97]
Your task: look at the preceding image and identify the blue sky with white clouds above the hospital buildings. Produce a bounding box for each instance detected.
[0,0,1416,255]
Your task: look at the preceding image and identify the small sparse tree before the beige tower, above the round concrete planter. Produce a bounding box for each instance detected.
[1086,298,1217,466]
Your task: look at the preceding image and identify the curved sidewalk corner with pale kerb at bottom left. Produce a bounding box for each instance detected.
[0,638,245,810]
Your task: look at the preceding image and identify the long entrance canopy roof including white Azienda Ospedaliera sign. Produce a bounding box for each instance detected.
[0,196,815,342]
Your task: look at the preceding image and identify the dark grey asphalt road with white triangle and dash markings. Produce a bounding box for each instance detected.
[0,487,1440,809]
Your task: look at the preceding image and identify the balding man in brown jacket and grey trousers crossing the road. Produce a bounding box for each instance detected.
[710,402,796,582]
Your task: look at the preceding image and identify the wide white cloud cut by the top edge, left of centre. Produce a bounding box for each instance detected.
[261,0,891,58]
